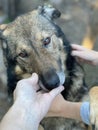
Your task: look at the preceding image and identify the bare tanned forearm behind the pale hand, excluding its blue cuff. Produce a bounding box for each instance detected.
[47,98,81,120]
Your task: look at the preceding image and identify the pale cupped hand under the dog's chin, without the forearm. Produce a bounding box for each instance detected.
[14,73,64,123]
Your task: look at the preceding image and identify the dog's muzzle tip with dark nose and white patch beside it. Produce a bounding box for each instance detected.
[39,71,66,92]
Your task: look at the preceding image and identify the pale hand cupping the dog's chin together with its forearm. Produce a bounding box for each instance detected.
[0,73,64,130]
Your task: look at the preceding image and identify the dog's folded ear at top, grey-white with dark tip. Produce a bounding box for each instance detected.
[38,5,61,20]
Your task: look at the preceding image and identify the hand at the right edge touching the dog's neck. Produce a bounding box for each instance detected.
[71,44,98,65]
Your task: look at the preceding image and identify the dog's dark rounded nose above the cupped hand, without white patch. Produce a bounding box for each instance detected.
[40,70,60,90]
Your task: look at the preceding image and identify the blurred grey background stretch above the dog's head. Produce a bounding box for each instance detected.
[0,0,96,43]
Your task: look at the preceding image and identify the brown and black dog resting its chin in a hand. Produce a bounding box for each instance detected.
[0,6,96,130]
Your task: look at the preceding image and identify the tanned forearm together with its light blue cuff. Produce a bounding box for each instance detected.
[47,98,90,125]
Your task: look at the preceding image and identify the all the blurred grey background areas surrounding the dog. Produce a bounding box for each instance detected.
[0,0,98,119]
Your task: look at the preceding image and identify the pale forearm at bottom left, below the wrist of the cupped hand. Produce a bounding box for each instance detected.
[0,102,38,130]
